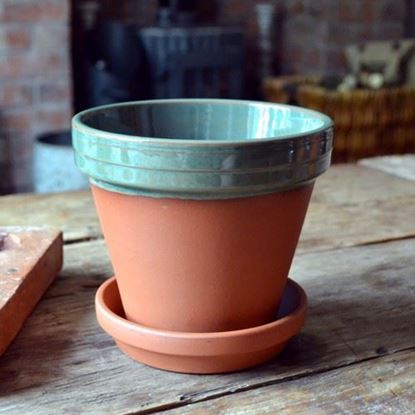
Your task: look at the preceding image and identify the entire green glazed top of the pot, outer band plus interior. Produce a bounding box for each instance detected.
[72,99,333,199]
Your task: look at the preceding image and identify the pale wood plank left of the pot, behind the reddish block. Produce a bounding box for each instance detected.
[0,192,101,241]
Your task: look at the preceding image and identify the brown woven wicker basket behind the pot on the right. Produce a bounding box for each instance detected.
[264,76,415,162]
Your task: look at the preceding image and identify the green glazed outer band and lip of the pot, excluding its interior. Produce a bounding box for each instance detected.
[72,99,333,199]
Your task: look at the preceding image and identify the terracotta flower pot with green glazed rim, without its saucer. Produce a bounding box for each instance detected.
[73,99,333,332]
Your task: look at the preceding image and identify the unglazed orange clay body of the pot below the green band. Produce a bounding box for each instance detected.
[92,185,312,332]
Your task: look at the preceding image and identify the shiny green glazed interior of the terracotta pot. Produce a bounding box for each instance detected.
[81,99,331,141]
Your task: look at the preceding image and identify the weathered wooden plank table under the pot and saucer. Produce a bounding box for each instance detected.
[0,156,415,415]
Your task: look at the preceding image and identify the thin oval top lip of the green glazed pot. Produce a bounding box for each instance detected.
[72,98,334,147]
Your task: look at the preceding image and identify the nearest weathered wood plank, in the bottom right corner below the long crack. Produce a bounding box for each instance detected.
[166,351,415,415]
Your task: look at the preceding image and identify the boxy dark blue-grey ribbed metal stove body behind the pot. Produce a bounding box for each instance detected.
[139,26,244,98]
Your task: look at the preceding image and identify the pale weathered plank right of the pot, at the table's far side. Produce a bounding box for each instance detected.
[298,165,415,252]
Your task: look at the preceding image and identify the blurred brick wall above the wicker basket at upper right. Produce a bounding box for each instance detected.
[279,0,407,74]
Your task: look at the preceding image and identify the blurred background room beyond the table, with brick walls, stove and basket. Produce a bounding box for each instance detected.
[0,0,415,194]
